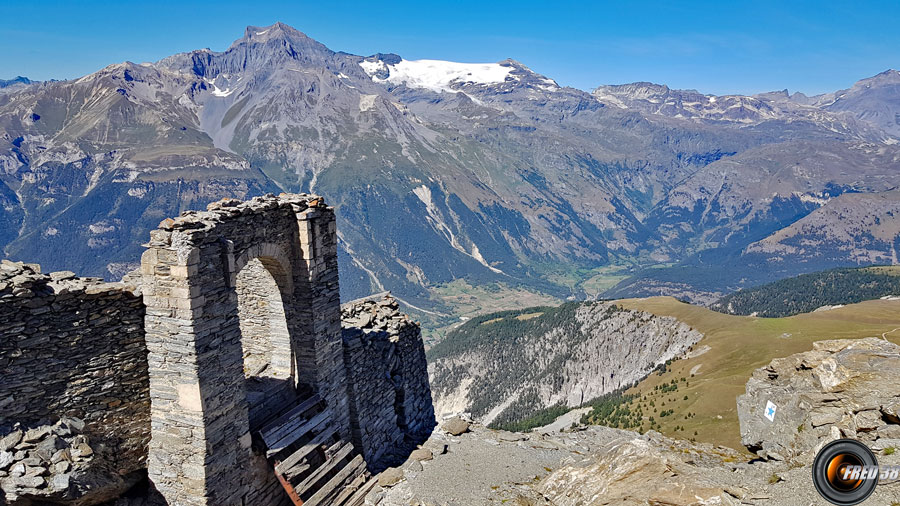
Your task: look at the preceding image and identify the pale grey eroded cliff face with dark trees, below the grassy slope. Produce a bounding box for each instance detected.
[429,302,702,424]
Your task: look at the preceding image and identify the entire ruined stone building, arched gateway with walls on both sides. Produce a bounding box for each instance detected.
[0,194,433,505]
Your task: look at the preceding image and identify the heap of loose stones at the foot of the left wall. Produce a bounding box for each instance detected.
[0,417,138,506]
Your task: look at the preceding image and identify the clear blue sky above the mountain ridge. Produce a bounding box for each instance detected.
[0,0,900,94]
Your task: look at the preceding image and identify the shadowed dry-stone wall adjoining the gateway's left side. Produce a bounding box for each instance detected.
[0,260,150,474]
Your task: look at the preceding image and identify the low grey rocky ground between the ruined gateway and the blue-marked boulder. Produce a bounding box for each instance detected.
[367,424,796,506]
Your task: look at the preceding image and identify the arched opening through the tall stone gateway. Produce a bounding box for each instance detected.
[235,257,297,427]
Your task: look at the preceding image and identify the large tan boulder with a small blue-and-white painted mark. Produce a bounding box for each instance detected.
[738,338,900,465]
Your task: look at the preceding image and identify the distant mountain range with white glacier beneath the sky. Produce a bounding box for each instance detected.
[0,23,900,322]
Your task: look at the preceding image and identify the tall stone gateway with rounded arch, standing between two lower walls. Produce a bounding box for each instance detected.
[141,194,349,505]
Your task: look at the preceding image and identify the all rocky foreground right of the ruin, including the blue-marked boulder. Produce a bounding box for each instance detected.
[367,338,900,506]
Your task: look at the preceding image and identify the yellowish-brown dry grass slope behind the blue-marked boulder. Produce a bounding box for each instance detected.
[620,297,900,448]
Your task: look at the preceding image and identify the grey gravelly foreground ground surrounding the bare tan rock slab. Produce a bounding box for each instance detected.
[366,425,900,506]
